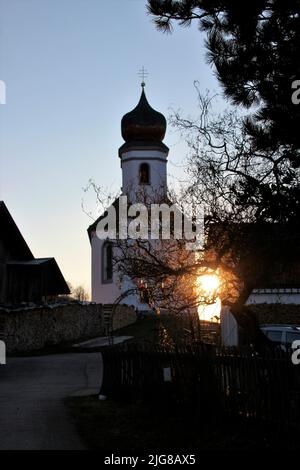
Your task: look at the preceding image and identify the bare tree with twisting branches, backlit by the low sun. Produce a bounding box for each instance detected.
[81,88,299,343]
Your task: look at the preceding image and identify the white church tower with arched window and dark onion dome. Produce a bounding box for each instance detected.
[119,83,169,202]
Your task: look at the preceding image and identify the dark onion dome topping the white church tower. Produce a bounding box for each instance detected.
[121,84,167,142]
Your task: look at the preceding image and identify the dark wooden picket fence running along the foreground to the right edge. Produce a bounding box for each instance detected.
[101,344,300,426]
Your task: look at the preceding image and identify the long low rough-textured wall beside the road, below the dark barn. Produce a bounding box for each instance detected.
[0,303,136,353]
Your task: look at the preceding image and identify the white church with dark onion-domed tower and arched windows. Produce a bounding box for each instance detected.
[88,82,169,311]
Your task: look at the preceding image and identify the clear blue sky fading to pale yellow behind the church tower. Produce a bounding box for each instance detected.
[0,0,220,289]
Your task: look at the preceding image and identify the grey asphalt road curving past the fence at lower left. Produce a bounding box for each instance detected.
[0,353,102,450]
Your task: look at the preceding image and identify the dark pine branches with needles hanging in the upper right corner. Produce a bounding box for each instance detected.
[148,0,300,184]
